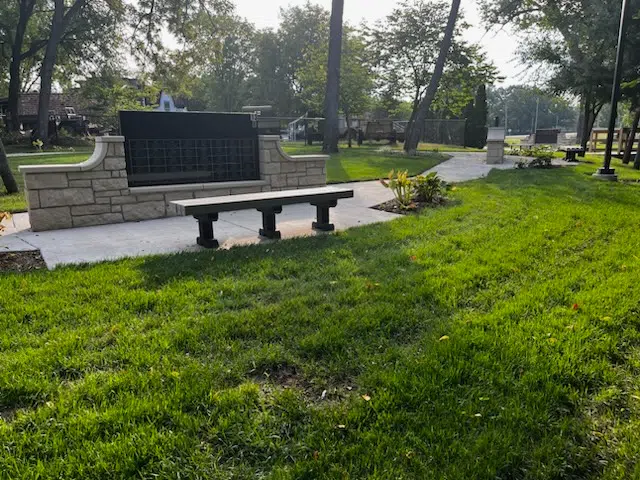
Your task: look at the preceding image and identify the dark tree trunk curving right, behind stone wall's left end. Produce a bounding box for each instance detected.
[37,0,87,144]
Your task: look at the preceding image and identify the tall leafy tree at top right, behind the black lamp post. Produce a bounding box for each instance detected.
[482,0,638,150]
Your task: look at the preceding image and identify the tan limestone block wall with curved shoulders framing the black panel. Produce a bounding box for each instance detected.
[20,136,329,231]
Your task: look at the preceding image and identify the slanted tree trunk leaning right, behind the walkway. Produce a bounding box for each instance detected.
[404,0,460,154]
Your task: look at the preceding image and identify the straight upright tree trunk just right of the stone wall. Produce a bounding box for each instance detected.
[322,0,344,153]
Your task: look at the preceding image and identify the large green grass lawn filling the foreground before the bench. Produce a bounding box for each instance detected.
[0,165,640,480]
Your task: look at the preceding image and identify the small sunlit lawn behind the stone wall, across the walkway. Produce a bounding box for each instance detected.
[283,143,448,183]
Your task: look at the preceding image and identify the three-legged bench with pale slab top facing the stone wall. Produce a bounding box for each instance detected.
[171,187,353,248]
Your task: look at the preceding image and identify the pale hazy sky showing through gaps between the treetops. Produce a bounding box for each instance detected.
[233,0,526,86]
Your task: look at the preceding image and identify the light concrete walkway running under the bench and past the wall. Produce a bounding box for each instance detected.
[0,153,564,268]
